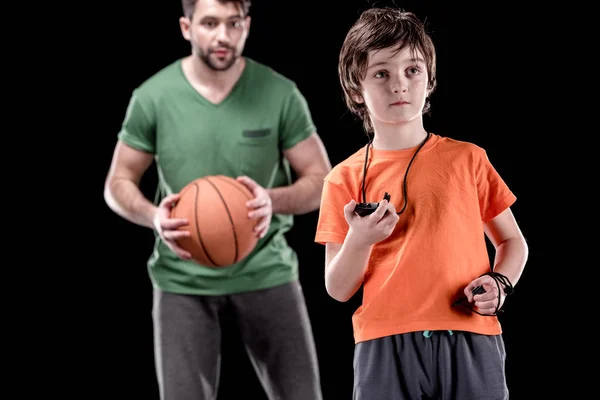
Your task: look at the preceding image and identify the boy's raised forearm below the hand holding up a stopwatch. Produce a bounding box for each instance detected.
[325,232,373,302]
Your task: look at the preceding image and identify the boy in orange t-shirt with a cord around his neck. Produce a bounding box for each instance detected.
[315,8,528,400]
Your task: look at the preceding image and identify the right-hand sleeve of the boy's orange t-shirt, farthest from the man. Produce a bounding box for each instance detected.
[477,151,517,223]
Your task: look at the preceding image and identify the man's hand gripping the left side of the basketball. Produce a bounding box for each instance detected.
[152,193,192,260]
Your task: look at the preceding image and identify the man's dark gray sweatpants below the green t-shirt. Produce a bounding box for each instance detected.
[152,281,322,400]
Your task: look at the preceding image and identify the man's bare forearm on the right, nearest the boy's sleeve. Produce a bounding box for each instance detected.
[268,174,324,214]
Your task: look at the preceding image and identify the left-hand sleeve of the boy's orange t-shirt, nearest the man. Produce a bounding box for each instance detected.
[315,179,351,244]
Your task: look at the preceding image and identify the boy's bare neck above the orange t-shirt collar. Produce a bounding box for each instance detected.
[373,119,427,150]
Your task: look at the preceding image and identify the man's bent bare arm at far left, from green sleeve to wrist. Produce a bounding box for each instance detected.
[104,141,157,228]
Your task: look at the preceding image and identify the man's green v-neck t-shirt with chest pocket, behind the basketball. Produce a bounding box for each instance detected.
[118,58,316,295]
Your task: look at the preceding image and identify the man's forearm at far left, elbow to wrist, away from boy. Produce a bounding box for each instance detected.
[104,178,156,229]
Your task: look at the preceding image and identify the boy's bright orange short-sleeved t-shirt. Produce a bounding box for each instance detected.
[315,134,516,343]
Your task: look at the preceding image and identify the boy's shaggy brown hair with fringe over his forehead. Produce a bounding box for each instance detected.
[338,7,436,133]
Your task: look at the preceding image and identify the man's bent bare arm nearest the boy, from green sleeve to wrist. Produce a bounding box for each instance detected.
[268,132,331,214]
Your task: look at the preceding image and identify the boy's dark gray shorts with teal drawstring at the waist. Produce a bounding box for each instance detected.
[353,331,508,400]
